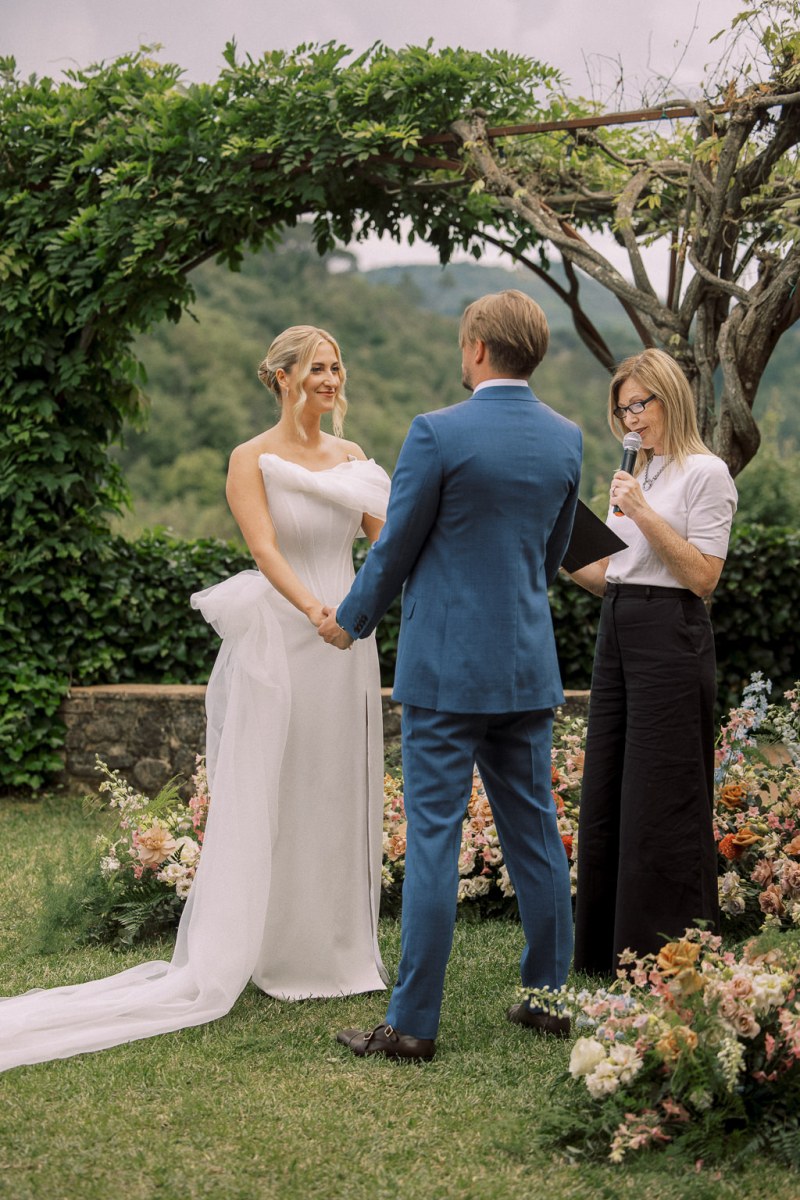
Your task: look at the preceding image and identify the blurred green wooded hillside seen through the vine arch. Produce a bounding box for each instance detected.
[115,227,800,538]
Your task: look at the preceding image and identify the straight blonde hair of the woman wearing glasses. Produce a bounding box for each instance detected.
[608,348,711,474]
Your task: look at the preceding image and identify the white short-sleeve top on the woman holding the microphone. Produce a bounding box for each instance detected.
[606,454,738,588]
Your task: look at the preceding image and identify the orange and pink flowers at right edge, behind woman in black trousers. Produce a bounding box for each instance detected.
[714,673,800,937]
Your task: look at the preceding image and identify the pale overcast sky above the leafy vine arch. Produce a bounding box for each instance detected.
[0,0,744,276]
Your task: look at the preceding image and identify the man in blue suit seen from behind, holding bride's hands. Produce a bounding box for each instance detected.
[319,290,582,1058]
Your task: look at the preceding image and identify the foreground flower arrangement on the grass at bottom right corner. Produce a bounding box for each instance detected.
[527,930,800,1166]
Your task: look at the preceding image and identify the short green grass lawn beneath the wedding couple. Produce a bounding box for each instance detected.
[0,798,800,1200]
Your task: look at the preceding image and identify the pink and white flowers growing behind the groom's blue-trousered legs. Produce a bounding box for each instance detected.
[381,718,585,916]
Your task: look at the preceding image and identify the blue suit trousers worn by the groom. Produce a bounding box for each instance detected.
[386,704,572,1038]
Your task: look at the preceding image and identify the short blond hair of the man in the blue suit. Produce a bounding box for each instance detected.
[458,288,551,379]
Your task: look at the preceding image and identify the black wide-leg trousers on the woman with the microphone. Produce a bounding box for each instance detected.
[575,584,720,974]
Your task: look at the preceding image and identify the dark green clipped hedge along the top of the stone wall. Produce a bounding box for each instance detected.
[64,527,800,709]
